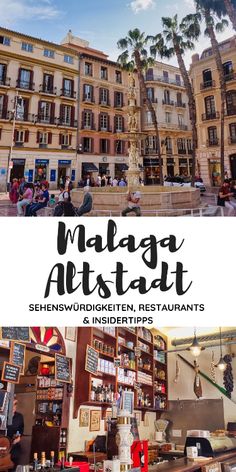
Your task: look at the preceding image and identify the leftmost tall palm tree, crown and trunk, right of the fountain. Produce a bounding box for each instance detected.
[117,28,163,185]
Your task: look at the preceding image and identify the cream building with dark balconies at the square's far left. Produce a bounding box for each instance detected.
[0,28,79,191]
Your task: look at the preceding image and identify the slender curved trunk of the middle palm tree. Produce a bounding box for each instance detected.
[173,38,198,187]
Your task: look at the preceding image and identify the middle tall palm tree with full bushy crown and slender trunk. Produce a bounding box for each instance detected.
[150,13,200,186]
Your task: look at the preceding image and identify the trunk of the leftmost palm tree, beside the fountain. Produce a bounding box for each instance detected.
[135,51,164,185]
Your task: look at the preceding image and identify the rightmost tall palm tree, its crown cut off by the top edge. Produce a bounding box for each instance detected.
[194,0,228,182]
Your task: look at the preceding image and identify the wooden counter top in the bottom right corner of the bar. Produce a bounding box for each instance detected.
[154,451,236,472]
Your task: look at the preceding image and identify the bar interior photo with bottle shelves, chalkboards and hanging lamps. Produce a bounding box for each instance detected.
[0,326,236,472]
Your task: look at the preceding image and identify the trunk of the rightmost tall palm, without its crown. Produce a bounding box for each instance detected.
[204,11,226,183]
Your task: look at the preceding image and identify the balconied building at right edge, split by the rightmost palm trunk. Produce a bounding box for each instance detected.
[190,36,236,185]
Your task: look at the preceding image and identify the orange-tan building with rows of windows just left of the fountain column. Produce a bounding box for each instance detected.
[62,32,131,179]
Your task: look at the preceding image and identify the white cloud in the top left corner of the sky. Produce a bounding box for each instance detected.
[0,0,59,26]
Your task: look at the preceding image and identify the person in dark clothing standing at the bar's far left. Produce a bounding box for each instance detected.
[7,399,24,466]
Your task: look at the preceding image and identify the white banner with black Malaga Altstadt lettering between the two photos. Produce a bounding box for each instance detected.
[0,218,236,327]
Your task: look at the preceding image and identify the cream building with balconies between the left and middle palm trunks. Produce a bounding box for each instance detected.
[142,62,192,184]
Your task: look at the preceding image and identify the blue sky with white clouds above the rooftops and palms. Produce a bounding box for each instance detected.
[0,0,233,64]
